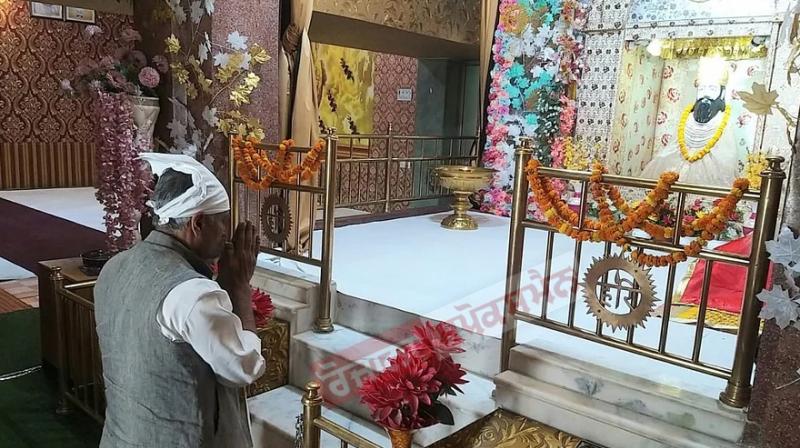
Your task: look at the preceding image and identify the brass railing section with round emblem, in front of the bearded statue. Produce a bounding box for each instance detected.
[501,139,786,408]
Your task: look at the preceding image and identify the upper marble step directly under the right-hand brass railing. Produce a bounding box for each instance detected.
[509,345,745,443]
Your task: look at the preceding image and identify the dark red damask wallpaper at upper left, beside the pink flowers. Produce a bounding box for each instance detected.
[0,0,132,143]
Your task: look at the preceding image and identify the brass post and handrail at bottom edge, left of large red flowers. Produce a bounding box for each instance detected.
[295,381,380,448]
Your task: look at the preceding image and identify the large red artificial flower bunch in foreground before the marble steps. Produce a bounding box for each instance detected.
[360,323,467,441]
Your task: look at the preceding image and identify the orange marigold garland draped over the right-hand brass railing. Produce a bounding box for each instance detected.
[527,159,750,266]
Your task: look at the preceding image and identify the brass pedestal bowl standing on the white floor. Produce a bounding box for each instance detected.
[435,165,496,230]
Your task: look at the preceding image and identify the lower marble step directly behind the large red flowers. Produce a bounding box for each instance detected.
[289,325,496,446]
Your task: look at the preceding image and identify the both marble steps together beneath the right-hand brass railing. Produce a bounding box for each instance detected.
[495,345,745,448]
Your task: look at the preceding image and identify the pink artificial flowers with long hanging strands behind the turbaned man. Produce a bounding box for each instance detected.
[61,25,167,256]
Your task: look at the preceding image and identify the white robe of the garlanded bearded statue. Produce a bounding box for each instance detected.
[642,112,739,188]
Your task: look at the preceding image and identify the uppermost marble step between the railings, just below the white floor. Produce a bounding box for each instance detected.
[336,292,500,378]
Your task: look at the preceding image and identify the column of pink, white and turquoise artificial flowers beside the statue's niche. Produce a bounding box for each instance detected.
[481,0,589,219]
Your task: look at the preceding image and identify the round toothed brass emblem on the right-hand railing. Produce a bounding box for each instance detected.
[581,255,657,330]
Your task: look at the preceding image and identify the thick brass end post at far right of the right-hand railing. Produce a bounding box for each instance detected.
[719,157,786,408]
